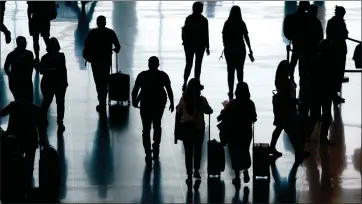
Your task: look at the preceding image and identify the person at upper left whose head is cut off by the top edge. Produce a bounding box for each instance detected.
[27,1,56,63]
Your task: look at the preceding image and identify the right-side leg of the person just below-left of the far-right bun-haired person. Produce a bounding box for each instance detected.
[320,97,332,144]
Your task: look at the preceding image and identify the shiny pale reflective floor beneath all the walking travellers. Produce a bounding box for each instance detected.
[0,1,361,203]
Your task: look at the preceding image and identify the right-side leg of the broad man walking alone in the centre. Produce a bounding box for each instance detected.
[152,107,165,159]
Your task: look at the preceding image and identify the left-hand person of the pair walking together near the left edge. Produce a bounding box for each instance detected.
[4,36,34,102]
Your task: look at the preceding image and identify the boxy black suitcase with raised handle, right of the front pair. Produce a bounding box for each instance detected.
[252,124,270,180]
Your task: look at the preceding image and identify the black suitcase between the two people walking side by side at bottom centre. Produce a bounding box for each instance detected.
[207,115,225,178]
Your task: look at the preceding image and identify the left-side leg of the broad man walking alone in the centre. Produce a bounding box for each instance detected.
[140,105,152,166]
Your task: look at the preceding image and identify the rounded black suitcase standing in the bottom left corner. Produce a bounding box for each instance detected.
[39,144,61,202]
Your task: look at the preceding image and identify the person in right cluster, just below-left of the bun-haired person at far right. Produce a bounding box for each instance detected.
[309,40,339,144]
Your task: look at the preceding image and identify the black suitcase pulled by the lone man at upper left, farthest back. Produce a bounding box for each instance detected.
[108,54,130,105]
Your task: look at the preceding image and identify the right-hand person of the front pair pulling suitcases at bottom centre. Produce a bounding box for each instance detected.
[217,82,257,187]
